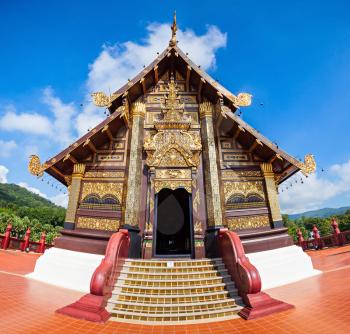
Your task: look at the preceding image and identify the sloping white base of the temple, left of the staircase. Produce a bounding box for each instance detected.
[26,247,104,293]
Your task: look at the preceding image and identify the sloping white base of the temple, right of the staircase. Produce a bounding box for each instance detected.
[246,246,322,290]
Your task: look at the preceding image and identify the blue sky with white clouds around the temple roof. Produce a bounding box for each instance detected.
[0,1,350,212]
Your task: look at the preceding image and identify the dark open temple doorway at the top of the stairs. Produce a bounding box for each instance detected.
[154,189,194,257]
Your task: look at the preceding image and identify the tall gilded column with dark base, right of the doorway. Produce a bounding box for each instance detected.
[199,101,223,257]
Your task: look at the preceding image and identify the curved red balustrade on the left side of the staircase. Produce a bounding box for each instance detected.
[56,230,130,322]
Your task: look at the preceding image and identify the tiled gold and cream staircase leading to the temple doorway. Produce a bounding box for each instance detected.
[107,259,242,324]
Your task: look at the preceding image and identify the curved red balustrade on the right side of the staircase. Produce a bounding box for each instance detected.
[218,228,294,320]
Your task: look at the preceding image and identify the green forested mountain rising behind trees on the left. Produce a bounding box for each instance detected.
[0,183,59,208]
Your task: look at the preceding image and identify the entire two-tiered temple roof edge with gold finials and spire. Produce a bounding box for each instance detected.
[29,15,316,185]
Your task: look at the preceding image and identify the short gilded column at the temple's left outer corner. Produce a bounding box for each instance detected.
[64,164,85,230]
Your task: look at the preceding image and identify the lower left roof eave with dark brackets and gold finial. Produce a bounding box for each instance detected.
[29,110,125,186]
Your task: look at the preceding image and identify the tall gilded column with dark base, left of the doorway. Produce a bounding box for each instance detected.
[123,102,146,258]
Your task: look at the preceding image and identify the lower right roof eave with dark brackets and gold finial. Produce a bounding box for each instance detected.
[226,112,316,184]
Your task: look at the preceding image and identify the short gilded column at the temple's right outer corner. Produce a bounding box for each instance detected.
[260,162,283,228]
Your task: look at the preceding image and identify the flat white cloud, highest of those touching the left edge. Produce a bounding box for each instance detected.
[0,105,52,135]
